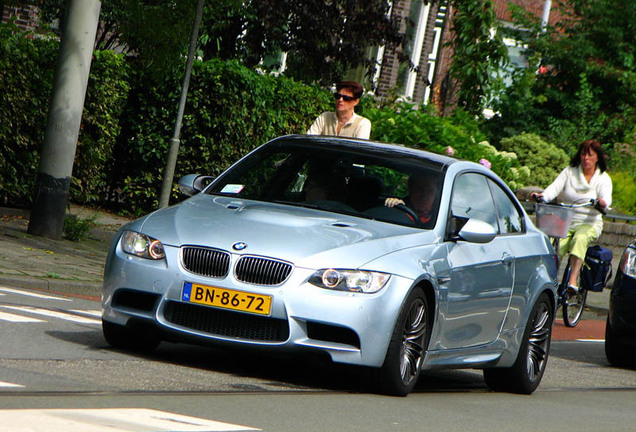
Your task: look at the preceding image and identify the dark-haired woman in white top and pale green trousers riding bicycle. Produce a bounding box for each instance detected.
[530,140,612,293]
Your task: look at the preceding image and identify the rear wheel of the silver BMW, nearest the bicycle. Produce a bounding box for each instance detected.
[484,293,554,394]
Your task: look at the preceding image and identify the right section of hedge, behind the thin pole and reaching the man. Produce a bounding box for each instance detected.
[110,60,333,214]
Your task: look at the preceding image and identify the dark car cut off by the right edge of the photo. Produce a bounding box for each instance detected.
[605,240,636,366]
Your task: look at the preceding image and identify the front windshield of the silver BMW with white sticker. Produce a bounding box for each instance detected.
[205,142,442,228]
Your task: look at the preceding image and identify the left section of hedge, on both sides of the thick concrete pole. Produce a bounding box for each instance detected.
[0,25,128,211]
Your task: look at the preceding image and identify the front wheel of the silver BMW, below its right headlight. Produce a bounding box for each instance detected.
[377,288,431,396]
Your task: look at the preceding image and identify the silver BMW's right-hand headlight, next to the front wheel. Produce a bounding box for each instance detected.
[309,269,391,293]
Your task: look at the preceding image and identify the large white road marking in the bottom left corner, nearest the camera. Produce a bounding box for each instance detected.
[0,408,261,432]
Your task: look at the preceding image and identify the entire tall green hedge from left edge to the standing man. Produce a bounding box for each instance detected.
[0,25,333,214]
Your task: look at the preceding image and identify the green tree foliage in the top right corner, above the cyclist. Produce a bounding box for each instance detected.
[484,0,636,153]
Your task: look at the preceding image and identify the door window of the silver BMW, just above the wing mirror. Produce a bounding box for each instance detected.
[451,173,497,229]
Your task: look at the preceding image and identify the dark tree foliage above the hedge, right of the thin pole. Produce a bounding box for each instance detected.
[203,0,400,84]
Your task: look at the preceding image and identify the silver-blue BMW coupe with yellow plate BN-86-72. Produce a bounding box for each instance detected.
[102,136,557,395]
